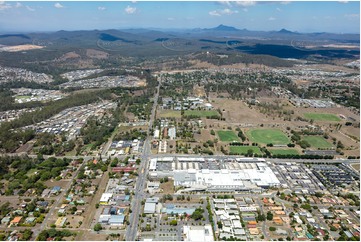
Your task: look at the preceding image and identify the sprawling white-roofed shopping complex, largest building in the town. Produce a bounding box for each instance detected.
[148,159,281,192]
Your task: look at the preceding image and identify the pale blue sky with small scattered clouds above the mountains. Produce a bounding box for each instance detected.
[0,1,360,33]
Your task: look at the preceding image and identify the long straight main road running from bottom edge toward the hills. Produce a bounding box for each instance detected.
[125,76,162,241]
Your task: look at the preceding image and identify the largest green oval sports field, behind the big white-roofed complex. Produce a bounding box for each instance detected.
[247,129,290,145]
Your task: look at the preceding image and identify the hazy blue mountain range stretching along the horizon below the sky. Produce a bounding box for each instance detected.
[0,24,360,58]
